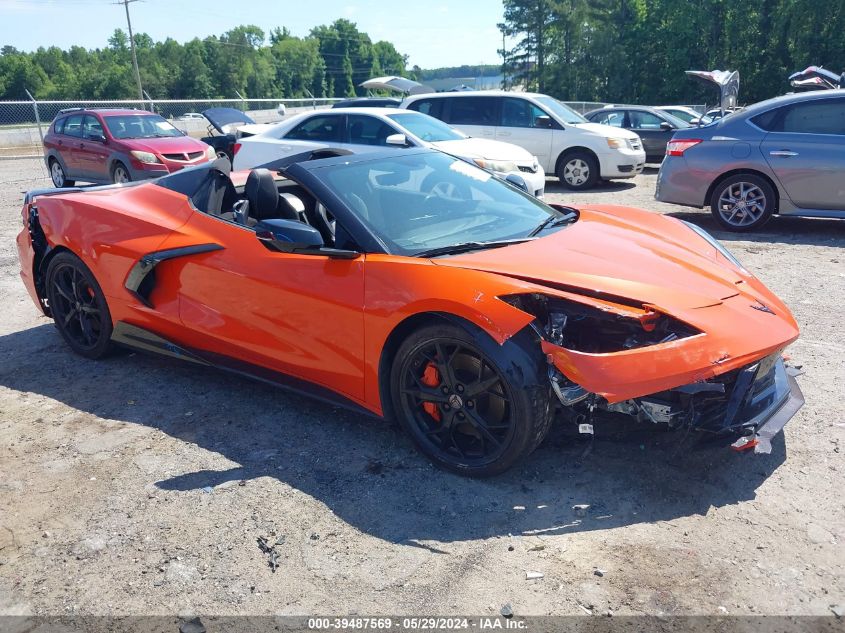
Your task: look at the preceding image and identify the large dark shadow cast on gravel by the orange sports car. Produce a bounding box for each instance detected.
[0,324,785,546]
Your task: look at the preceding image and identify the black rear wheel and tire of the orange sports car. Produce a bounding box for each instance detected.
[46,253,112,359]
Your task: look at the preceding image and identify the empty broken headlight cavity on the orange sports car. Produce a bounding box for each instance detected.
[500,294,701,354]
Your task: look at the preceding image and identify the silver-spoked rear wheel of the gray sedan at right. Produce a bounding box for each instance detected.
[710,174,777,232]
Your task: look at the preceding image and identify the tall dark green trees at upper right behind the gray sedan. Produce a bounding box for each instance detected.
[499,0,845,104]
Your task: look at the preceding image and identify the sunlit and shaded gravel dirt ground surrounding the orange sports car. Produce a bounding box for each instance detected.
[0,160,845,615]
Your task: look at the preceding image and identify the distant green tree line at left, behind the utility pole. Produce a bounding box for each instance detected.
[0,19,407,100]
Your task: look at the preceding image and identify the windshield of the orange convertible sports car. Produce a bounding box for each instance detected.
[313,152,564,256]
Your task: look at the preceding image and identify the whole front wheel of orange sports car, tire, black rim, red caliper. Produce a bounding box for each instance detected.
[390,324,552,477]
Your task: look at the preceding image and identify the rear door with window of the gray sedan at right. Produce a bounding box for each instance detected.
[753,97,845,210]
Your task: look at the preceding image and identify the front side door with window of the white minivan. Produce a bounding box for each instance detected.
[496,97,552,165]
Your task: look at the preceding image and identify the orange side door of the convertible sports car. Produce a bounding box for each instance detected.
[168,205,364,400]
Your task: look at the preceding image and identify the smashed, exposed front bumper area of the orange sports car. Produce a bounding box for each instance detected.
[549,351,804,454]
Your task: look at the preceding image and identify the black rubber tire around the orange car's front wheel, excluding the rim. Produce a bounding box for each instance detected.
[389,321,551,477]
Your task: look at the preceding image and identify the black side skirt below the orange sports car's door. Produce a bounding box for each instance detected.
[112,321,382,419]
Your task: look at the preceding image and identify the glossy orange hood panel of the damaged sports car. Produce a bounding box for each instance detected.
[433,206,750,311]
